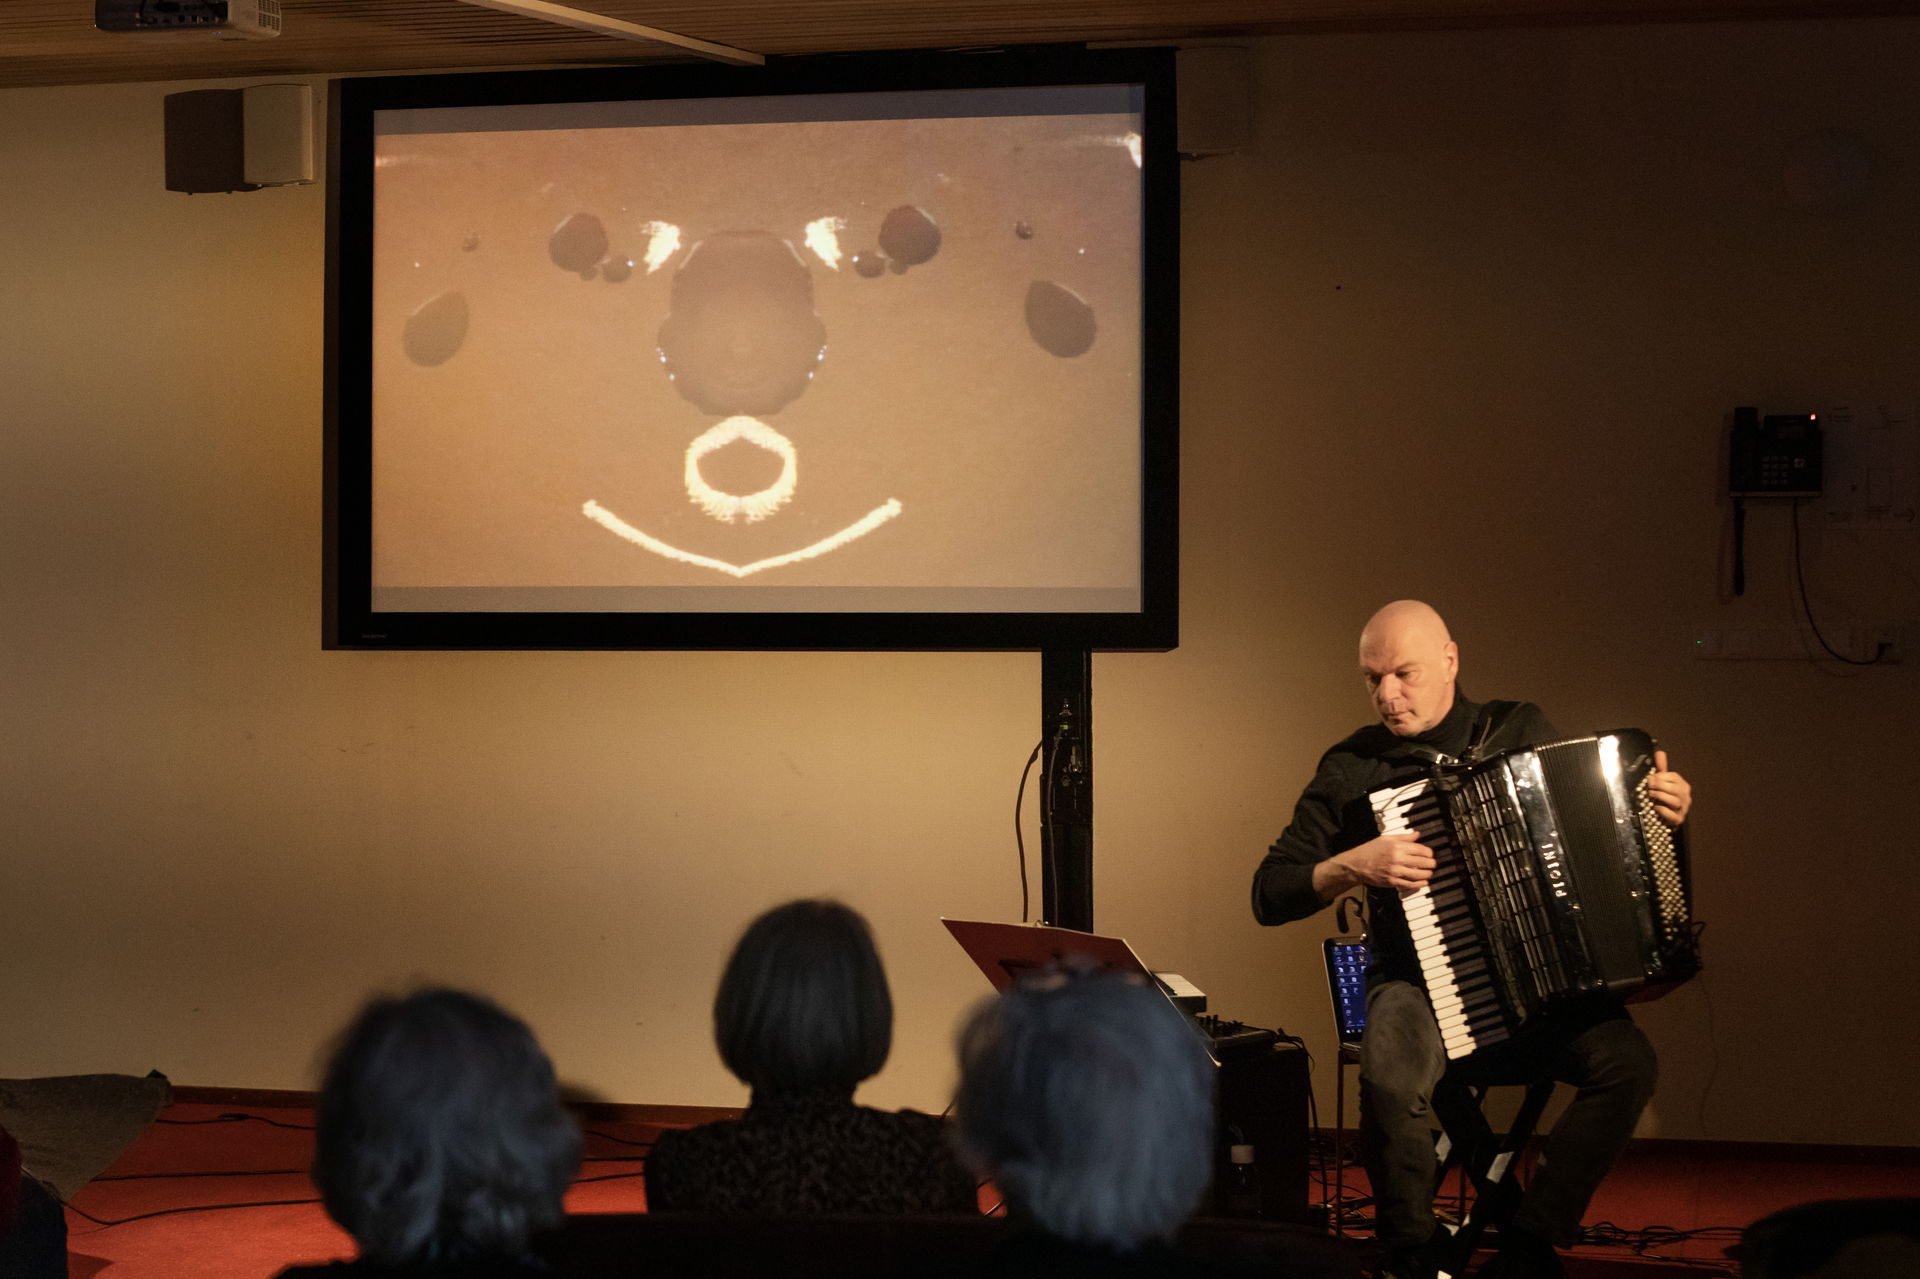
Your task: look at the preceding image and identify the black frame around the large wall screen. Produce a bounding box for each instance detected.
[323,48,1179,651]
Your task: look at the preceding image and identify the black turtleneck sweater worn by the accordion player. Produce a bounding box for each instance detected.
[1254,686,1557,981]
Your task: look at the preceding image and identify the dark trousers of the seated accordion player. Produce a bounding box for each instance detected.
[1359,981,1659,1248]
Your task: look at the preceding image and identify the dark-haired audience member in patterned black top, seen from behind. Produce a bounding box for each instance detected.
[647,901,977,1216]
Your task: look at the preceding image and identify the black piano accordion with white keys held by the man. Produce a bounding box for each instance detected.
[1369,728,1699,1058]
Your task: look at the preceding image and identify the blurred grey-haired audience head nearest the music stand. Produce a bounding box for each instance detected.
[954,976,1213,1252]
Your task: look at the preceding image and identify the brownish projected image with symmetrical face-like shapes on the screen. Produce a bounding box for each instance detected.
[372,90,1140,613]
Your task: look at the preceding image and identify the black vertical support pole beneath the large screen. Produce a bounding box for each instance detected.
[1041,649,1092,933]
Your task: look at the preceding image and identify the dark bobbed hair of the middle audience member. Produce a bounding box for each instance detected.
[714,901,893,1095]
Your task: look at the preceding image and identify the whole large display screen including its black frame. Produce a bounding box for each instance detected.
[328,52,1177,647]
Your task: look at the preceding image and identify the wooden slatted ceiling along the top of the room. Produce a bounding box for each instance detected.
[0,0,1920,88]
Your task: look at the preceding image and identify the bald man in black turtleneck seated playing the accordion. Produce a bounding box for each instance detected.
[1254,599,1693,1279]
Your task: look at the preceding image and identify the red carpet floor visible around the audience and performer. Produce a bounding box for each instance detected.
[56,1104,1920,1279]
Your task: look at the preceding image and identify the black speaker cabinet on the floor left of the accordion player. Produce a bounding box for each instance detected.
[1208,1031,1309,1223]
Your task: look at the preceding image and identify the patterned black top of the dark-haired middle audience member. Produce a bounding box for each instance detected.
[647,1091,979,1216]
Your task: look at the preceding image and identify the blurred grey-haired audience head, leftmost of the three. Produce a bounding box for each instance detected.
[313,989,580,1266]
